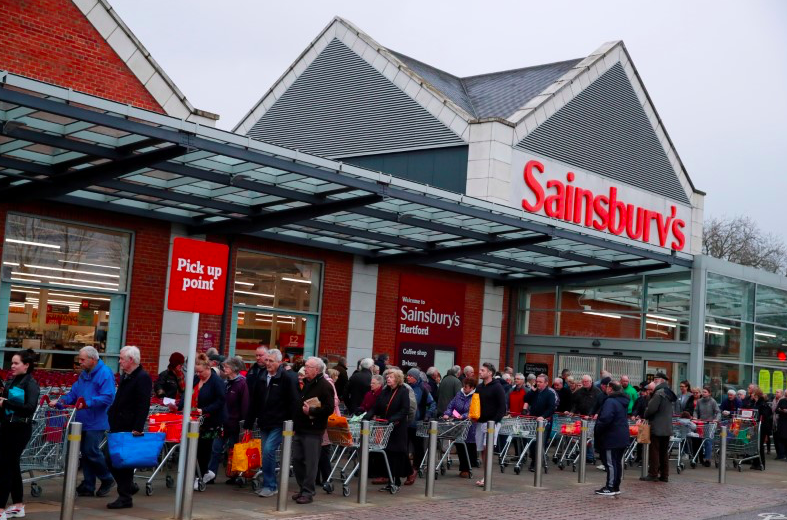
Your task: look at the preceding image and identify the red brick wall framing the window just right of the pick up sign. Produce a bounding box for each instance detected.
[199,237,353,358]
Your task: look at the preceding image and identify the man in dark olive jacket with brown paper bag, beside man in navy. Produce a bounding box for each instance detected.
[640,372,678,482]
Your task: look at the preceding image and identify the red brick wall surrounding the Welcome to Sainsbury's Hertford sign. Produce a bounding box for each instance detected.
[372,265,484,368]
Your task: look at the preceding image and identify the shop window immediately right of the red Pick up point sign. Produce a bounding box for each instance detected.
[230,251,322,362]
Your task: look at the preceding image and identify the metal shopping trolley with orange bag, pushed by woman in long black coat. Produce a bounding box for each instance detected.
[323,421,392,497]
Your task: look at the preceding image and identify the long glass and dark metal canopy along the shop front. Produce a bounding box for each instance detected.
[0,72,692,284]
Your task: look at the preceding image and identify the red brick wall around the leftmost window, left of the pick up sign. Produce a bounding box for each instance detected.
[0,202,170,368]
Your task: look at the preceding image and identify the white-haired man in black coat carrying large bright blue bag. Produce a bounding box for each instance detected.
[107,346,153,509]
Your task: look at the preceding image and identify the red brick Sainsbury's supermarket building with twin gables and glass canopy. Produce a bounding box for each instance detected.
[0,0,787,393]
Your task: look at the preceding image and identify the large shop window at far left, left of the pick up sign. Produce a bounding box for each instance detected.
[0,213,131,370]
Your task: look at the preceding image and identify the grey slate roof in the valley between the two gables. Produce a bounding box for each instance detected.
[390,51,582,119]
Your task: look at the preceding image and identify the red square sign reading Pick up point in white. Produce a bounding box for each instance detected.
[167,238,229,315]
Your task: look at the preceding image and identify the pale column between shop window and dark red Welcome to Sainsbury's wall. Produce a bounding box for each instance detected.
[347,256,377,372]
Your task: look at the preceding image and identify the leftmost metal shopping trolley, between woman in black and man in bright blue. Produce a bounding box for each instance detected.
[19,396,77,498]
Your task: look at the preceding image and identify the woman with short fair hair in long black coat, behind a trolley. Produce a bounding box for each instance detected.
[367,369,413,491]
